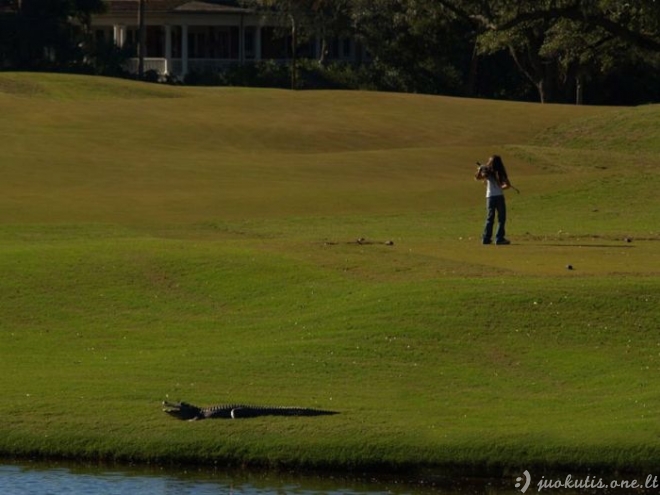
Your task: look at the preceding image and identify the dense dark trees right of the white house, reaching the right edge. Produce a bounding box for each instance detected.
[244,0,660,104]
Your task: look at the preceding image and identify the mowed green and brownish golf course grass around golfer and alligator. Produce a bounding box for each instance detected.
[0,73,660,473]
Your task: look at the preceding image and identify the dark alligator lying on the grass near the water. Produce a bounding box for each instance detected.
[163,401,338,421]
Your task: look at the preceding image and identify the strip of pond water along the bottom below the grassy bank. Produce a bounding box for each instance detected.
[0,457,660,495]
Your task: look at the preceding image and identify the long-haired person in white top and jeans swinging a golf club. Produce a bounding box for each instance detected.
[474,155,515,245]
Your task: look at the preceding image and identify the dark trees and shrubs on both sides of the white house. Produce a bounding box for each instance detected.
[0,0,660,104]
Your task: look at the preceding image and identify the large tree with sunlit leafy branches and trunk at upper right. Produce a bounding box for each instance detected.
[437,0,660,102]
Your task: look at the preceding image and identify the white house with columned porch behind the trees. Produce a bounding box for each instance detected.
[91,0,356,78]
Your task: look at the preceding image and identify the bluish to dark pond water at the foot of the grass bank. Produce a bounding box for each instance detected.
[0,461,660,495]
